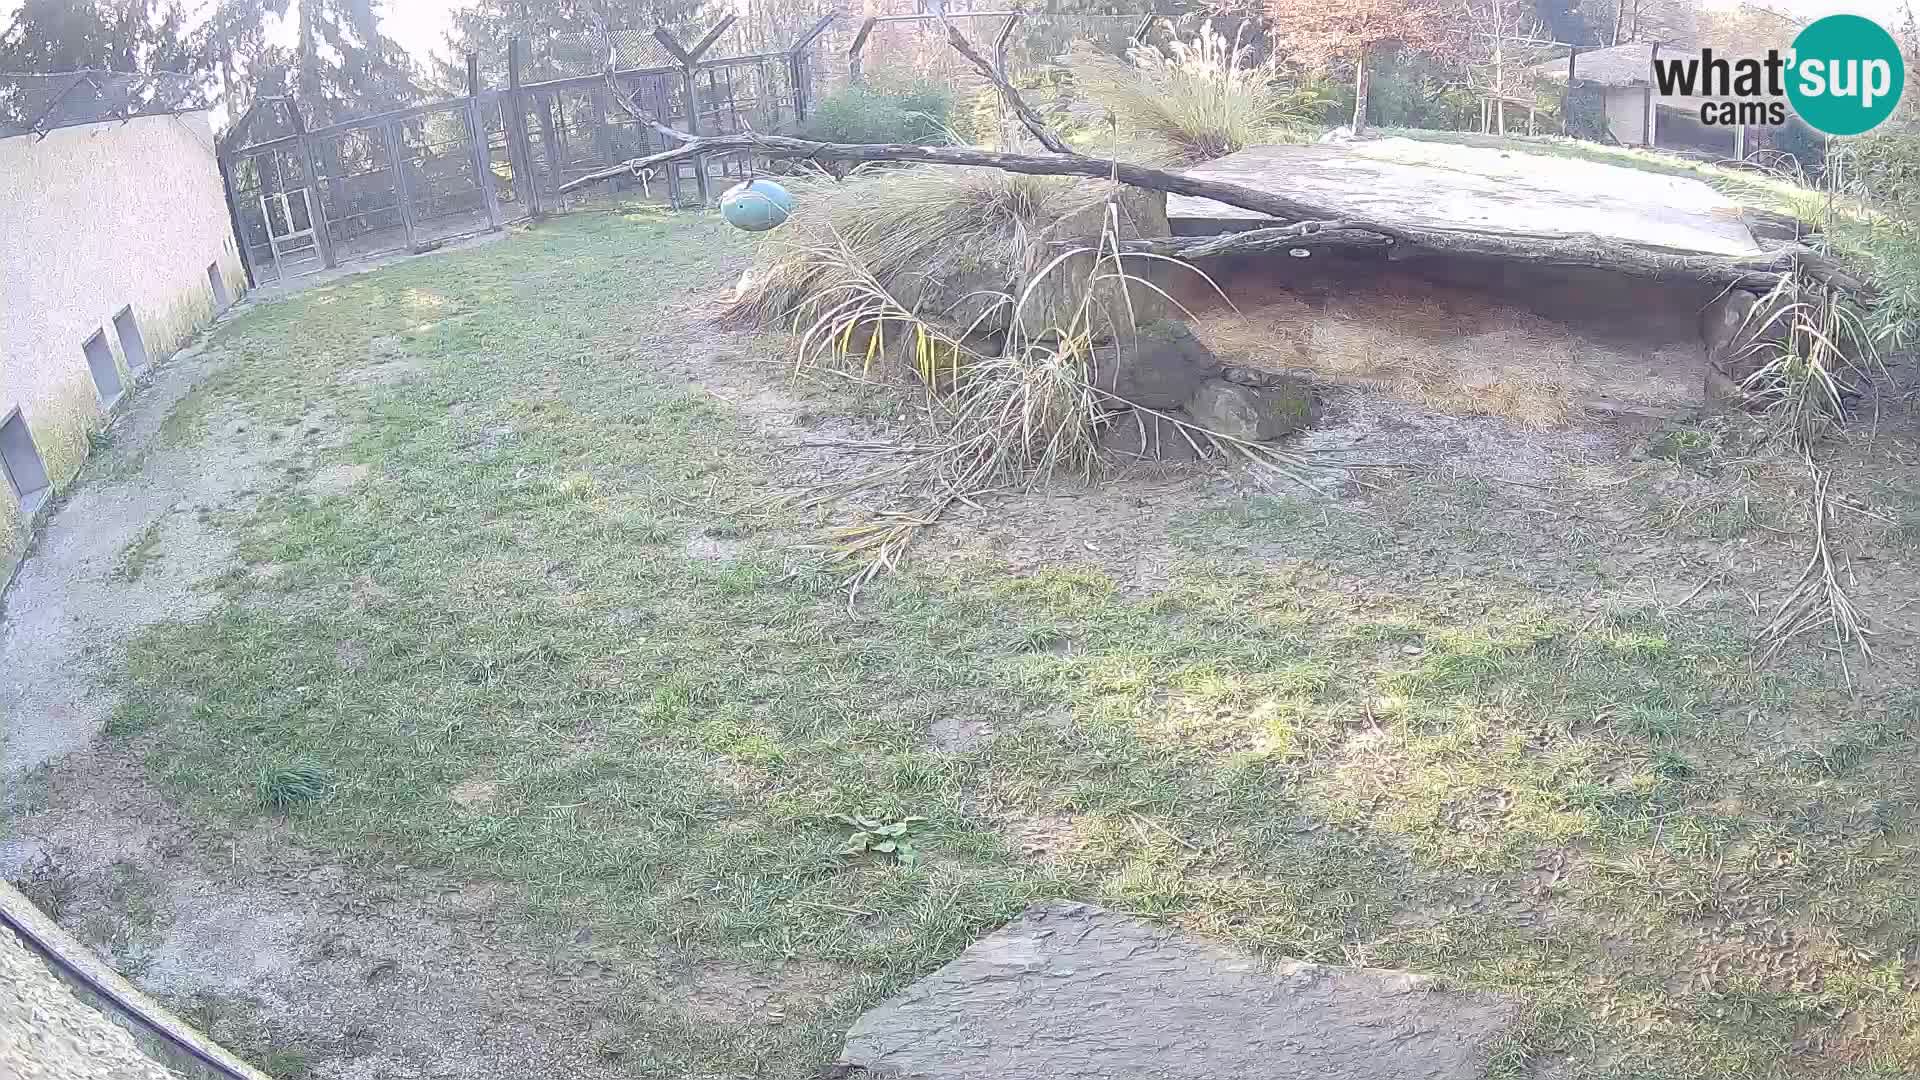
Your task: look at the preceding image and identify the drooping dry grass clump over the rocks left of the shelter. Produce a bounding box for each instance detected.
[735,179,1304,591]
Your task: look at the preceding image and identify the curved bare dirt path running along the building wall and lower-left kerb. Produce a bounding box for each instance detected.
[0,295,714,1080]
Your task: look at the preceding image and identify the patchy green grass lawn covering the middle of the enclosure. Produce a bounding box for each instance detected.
[86,209,1920,1078]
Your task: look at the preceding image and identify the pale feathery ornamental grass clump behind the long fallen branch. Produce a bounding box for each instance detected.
[1069,23,1311,165]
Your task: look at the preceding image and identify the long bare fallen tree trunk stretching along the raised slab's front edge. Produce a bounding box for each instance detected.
[561,133,1874,302]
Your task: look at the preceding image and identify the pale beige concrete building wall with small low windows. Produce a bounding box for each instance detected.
[0,111,246,580]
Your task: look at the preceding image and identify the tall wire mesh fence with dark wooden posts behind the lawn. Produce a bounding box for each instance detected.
[223,0,1142,281]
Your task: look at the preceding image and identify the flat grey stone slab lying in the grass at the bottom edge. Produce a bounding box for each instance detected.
[839,903,1517,1080]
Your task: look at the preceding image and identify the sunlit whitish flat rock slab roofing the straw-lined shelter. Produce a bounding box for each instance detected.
[1167,138,1759,256]
